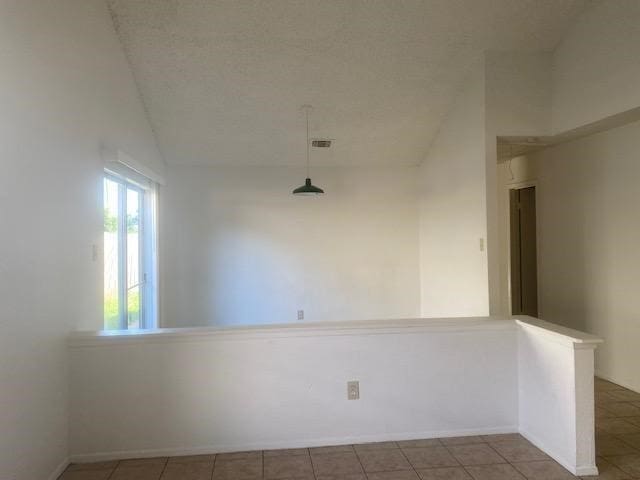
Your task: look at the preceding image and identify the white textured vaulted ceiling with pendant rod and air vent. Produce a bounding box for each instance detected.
[109,0,587,165]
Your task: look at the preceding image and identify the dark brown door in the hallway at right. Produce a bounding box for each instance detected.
[510,187,538,317]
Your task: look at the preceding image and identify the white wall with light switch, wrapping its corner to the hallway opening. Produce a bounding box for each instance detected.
[420,52,551,316]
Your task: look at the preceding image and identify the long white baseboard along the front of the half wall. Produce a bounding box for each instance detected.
[70,425,518,463]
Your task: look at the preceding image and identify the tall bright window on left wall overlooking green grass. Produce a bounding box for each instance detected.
[103,171,157,330]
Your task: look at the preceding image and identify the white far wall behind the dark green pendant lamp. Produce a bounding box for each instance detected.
[160,167,420,327]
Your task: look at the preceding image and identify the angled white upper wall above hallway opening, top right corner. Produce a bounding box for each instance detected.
[552,0,640,133]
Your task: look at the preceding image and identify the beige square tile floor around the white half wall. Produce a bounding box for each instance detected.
[59,379,640,480]
